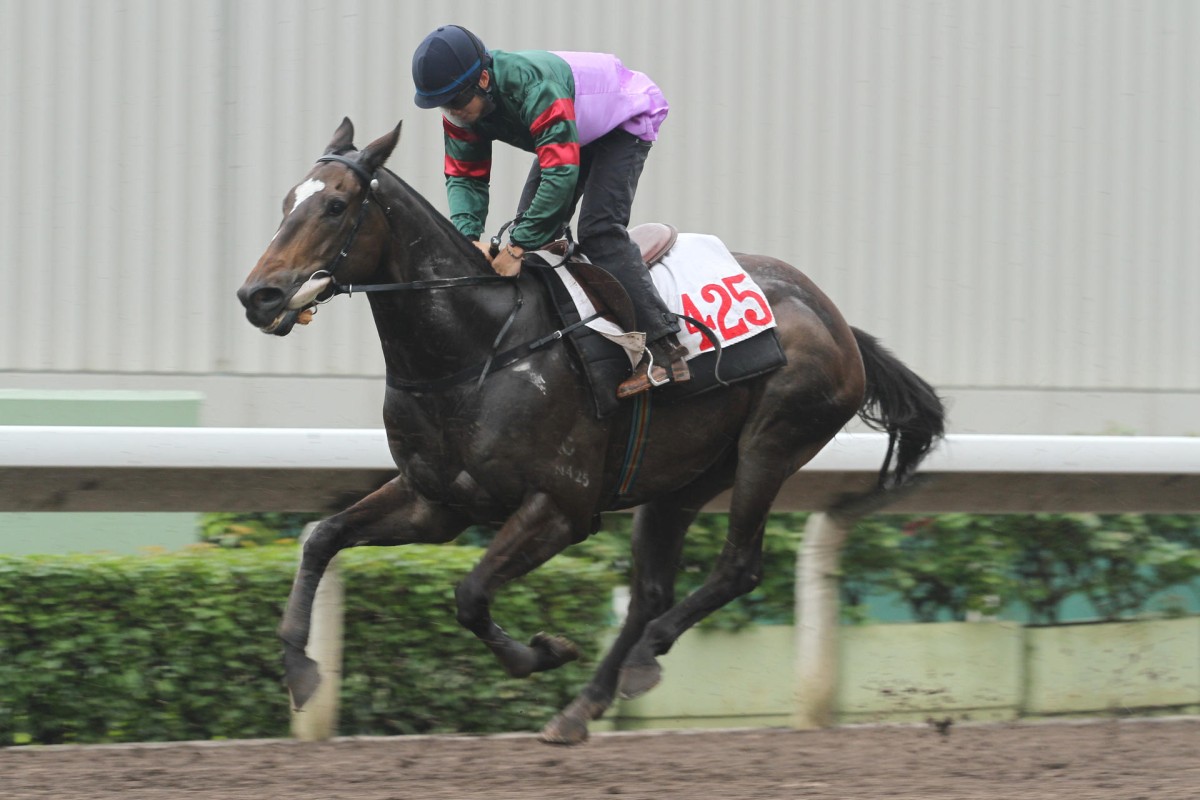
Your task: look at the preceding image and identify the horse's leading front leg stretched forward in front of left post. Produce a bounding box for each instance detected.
[280,477,468,709]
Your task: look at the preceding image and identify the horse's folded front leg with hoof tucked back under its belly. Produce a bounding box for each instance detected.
[455,493,588,678]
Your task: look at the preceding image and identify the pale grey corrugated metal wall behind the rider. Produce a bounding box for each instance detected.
[0,0,1200,391]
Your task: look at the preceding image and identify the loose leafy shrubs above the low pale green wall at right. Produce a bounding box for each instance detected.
[570,513,1200,630]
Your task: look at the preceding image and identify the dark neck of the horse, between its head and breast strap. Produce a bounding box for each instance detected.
[370,179,515,380]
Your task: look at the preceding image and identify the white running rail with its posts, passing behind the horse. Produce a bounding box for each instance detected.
[0,426,1200,738]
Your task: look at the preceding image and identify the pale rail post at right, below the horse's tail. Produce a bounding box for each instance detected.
[794,512,854,728]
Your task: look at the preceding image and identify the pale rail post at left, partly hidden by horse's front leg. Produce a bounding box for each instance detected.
[292,523,344,741]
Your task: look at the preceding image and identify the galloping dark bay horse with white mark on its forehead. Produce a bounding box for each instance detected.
[238,120,943,744]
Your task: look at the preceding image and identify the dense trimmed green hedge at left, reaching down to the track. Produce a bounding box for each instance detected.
[0,546,614,745]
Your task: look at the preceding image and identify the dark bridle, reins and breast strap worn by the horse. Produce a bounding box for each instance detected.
[308,154,600,395]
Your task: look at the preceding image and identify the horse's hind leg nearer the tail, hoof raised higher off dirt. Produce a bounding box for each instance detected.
[618,439,828,698]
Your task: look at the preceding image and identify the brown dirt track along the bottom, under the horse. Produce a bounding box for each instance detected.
[0,718,1200,800]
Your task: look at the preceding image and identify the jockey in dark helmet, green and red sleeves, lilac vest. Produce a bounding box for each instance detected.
[413,25,691,397]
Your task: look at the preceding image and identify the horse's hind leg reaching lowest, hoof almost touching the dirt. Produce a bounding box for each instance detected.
[541,501,698,745]
